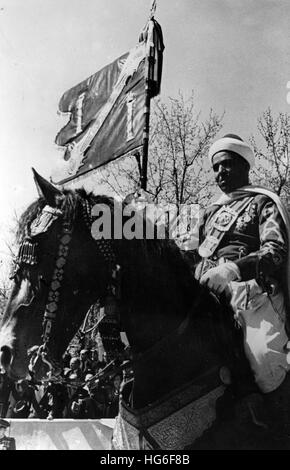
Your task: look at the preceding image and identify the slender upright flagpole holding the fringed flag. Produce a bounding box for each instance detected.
[140,0,156,191]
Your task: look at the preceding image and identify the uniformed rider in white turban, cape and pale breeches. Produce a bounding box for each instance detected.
[196,134,290,434]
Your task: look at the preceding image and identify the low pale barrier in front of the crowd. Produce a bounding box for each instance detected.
[6,419,115,450]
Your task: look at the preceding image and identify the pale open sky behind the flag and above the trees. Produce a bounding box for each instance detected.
[0,0,290,264]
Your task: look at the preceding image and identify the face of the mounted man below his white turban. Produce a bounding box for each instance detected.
[212,152,249,193]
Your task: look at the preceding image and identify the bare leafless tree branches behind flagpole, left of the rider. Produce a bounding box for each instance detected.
[98,93,223,206]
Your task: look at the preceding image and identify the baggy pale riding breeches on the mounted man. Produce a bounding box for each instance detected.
[227,279,290,393]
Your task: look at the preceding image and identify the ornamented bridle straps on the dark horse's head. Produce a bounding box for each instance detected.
[30,200,120,381]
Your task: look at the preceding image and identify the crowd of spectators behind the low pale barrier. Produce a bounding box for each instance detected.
[0,349,131,419]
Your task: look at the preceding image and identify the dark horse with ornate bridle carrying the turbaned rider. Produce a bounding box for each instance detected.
[0,175,284,449]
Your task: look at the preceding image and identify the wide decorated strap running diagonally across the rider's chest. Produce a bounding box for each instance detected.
[198,197,254,258]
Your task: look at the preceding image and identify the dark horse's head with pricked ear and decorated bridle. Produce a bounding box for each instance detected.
[0,174,114,380]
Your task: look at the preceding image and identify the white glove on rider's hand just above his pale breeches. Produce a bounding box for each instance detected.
[200,261,241,295]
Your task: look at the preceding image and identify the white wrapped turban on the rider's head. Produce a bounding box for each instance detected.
[208,135,255,168]
